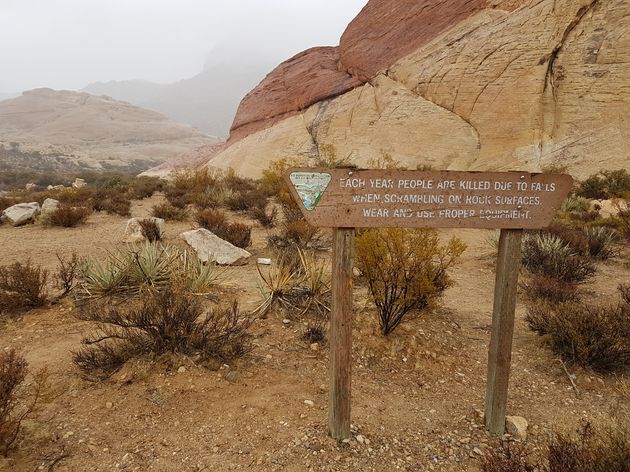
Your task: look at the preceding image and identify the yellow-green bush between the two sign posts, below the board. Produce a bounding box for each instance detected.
[356,228,466,336]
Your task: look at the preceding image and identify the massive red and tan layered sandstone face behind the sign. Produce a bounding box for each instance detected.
[210,0,630,177]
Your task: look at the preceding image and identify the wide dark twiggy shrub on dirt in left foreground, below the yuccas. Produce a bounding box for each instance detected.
[73,286,251,376]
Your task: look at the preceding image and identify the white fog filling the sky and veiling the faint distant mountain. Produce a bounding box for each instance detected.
[0,0,366,136]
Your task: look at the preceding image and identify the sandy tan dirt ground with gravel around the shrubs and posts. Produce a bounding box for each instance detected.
[0,197,630,472]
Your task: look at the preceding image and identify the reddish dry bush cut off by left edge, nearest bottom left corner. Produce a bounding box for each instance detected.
[0,349,47,456]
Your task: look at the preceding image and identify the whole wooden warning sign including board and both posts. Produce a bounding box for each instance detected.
[286,168,573,439]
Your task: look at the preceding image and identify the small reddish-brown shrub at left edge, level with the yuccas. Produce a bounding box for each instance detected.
[0,260,48,313]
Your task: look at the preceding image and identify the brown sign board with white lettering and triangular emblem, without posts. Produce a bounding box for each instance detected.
[285,168,573,229]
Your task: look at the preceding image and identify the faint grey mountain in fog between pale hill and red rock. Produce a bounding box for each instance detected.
[82,60,270,136]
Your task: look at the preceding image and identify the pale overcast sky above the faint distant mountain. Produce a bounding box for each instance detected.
[0,0,367,93]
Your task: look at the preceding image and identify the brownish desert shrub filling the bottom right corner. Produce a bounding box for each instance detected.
[547,414,630,472]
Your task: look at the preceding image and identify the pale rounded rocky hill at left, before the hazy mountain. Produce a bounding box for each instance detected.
[0,89,218,172]
